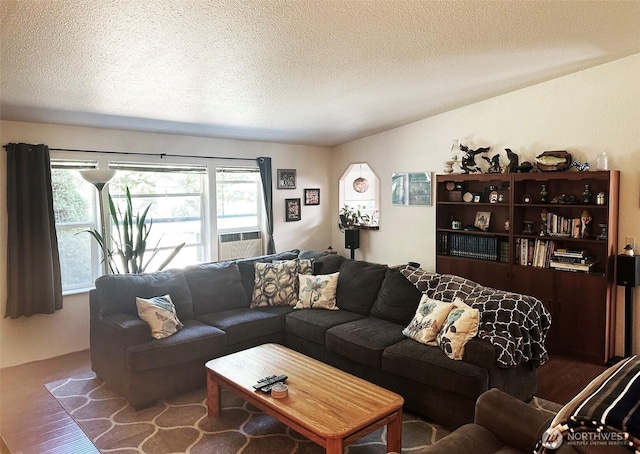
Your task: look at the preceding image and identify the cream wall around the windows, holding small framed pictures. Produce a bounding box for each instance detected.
[0,121,336,368]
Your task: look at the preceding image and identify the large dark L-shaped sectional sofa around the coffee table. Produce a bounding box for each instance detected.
[90,250,548,428]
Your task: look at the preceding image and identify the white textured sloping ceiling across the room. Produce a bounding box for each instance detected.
[0,0,640,146]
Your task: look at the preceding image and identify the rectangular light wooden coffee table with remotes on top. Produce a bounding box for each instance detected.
[206,344,404,454]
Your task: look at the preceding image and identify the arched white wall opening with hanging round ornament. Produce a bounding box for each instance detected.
[340,162,380,227]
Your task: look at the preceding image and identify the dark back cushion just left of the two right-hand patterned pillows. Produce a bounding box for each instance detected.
[371,268,422,326]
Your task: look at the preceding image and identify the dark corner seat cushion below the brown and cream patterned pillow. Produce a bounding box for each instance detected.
[198,309,283,346]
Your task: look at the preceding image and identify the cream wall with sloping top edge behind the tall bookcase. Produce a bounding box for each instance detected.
[332,54,640,354]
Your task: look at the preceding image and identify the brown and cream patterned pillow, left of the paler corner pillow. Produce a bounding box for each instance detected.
[251,260,302,309]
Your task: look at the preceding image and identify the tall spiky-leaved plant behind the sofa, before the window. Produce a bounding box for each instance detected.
[85,188,185,274]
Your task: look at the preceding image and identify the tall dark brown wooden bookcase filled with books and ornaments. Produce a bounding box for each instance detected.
[436,171,620,364]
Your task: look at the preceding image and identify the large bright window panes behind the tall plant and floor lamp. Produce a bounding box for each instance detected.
[51,159,210,291]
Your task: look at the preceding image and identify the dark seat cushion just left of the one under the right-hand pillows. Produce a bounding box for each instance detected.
[327,317,405,369]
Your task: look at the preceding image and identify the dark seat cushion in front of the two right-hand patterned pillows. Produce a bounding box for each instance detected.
[381,339,489,400]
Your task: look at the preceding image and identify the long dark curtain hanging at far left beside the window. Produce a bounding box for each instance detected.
[5,143,62,318]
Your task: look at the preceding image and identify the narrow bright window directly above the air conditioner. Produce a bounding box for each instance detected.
[216,167,262,232]
